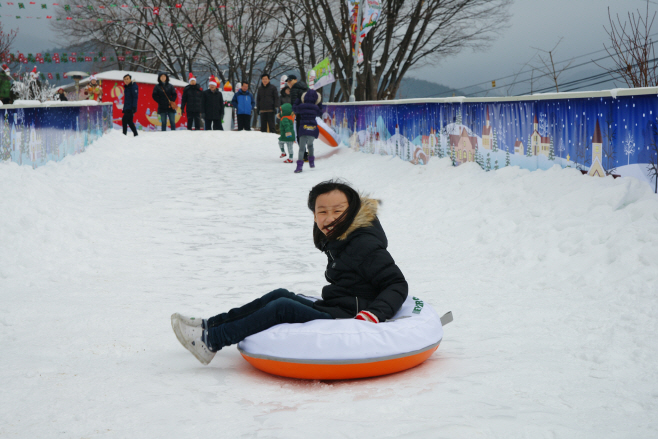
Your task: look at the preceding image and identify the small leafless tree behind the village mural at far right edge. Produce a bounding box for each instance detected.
[604,1,658,87]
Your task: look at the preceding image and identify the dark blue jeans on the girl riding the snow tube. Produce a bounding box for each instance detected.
[208,288,333,351]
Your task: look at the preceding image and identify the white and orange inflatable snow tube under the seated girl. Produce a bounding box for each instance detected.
[238,297,443,380]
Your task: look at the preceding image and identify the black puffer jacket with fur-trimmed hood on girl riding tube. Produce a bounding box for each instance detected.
[313,198,409,322]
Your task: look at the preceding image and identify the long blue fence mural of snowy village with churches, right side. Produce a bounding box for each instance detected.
[323,95,658,192]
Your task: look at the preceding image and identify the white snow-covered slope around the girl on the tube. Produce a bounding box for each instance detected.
[0,131,658,439]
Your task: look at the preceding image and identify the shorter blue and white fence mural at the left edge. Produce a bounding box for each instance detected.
[0,105,112,168]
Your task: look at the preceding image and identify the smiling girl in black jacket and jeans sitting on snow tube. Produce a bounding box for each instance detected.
[171,180,408,364]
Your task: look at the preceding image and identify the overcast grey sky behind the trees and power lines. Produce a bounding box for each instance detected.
[0,0,658,93]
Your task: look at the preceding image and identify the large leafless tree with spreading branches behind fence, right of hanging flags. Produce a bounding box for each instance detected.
[301,0,511,100]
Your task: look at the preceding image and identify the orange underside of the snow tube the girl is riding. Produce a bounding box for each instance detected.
[240,345,439,380]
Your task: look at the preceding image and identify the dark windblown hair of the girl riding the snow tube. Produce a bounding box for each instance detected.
[308,180,361,250]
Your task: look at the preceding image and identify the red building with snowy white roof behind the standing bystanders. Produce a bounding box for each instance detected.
[65,70,188,131]
